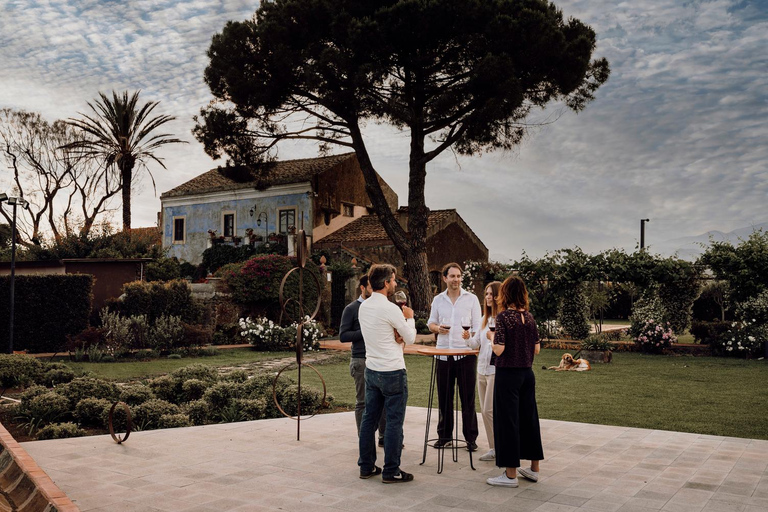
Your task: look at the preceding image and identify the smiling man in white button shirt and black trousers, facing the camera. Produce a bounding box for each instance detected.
[428,263,482,451]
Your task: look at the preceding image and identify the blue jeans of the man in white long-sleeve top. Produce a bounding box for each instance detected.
[357,368,408,478]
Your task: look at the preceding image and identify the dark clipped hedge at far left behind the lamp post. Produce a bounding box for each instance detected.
[0,274,93,353]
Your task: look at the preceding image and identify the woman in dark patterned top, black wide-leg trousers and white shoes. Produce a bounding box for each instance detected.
[487,276,544,487]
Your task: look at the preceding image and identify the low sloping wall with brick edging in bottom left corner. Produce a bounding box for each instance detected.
[0,424,80,512]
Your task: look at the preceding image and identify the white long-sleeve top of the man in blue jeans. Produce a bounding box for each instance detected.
[357,292,416,372]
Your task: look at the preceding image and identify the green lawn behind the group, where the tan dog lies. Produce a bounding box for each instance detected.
[286,349,768,439]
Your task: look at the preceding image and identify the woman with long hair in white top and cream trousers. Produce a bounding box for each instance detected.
[463,281,501,460]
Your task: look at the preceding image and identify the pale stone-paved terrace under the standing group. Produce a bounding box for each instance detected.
[21,408,768,512]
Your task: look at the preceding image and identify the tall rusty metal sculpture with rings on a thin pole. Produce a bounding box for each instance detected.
[272,221,326,441]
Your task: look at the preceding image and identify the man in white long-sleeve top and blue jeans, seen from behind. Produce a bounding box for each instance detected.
[357,265,416,484]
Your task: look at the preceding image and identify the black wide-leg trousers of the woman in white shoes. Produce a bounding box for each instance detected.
[493,366,544,468]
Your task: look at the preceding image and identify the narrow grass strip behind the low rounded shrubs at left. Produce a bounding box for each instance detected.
[64,348,295,382]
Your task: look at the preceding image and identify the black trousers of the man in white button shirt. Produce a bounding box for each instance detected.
[437,356,477,443]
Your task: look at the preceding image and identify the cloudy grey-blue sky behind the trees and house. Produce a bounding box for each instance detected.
[0,0,768,261]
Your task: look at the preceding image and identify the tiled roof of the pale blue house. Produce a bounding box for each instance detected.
[160,153,355,198]
